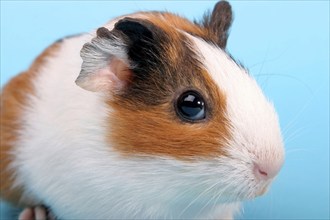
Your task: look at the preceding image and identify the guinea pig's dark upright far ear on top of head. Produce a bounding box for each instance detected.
[203,1,233,49]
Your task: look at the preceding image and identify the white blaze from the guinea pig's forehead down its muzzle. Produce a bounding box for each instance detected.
[187,35,284,198]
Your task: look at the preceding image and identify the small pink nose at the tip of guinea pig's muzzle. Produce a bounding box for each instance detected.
[253,161,281,180]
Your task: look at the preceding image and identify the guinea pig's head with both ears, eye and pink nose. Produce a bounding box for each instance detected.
[76,2,284,201]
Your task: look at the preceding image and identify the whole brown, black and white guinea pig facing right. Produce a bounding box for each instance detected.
[1,1,284,219]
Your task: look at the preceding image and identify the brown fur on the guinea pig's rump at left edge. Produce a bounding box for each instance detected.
[0,44,59,205]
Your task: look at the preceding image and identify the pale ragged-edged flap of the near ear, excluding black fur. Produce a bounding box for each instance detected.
[76,27,132,92]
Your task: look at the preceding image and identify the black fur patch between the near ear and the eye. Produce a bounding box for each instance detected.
[97,18,213,109]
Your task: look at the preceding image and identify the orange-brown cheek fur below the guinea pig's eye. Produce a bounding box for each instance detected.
[108,102,229,160]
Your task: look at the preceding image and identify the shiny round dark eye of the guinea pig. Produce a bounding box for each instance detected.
[176,91,205,122]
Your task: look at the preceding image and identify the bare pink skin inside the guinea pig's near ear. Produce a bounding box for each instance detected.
[89,58,132,92]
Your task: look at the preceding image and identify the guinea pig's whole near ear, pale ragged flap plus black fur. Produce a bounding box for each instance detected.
[76,18,161,93]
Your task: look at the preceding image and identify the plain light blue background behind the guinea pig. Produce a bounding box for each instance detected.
[1,1,329,219]
